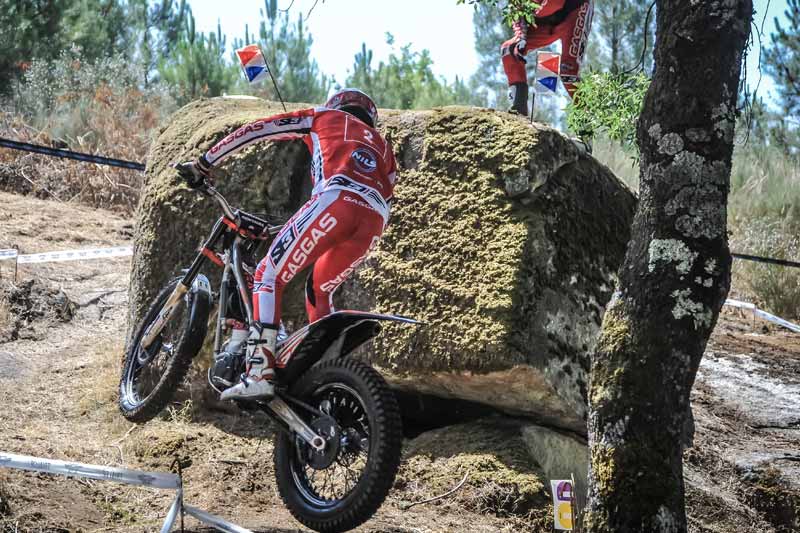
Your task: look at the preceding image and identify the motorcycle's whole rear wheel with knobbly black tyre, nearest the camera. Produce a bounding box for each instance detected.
[274,359,403,533]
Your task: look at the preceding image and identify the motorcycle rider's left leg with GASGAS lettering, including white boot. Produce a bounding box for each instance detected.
[221,191,353,400]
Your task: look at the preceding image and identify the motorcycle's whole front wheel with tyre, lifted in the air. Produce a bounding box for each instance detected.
[119,278,211,423]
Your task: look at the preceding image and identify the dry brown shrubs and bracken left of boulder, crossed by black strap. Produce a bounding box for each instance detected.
[0,48,176,212]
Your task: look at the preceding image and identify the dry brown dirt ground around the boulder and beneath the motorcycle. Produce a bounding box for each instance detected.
[0,193,800,533]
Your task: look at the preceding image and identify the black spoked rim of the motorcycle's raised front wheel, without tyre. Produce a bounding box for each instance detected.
[122,295,189,409]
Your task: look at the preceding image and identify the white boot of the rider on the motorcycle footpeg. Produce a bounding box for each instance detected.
[220,324,278,400]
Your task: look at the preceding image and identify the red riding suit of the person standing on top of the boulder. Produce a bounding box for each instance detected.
[500,0,594,98]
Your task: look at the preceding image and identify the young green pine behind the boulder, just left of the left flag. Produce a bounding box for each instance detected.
[158,14,236,105]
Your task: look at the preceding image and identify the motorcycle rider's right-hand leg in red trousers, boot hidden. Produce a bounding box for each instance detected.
[306,194,384,322]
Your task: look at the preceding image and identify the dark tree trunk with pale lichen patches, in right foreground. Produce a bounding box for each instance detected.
[584,0,753,533]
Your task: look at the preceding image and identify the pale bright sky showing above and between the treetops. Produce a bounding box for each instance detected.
[189,0,787,103]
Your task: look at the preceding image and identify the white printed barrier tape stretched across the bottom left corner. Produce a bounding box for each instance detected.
[0,453,181,490]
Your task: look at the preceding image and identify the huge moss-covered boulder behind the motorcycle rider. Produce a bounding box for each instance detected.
[130,99,635,431]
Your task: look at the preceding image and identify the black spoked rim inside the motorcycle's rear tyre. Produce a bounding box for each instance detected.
[290,383,371,508]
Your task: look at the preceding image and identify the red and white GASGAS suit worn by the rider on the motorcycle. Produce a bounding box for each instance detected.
[202,107,397,324]
